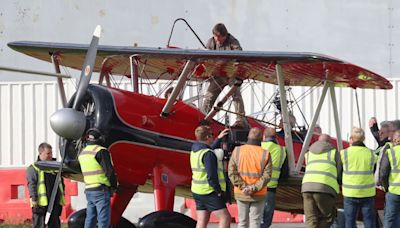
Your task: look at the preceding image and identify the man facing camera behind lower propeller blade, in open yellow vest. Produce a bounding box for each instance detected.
[26,142,65,228]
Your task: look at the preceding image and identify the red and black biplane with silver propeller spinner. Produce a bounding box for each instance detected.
[4,25,392,225]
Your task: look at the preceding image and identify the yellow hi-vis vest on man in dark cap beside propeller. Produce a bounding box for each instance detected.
[78,145,111,188]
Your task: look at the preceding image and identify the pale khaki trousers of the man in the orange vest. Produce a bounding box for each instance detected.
[236,200,265,228]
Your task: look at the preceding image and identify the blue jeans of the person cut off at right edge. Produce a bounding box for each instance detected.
[383,192,400,228]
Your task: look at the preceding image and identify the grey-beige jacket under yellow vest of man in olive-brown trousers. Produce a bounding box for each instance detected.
[301,141,343,197]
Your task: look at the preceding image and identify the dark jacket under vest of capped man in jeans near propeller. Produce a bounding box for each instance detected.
[86,142,118,191]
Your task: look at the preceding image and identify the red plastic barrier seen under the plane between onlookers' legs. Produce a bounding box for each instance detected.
[185,199,304,223]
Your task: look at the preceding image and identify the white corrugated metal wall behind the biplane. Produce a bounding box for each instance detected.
[0,79,400,167]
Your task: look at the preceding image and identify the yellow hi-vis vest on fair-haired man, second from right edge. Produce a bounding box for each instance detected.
[340,146,378,198]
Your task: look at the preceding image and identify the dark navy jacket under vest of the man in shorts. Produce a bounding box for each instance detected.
[191,142,222,193]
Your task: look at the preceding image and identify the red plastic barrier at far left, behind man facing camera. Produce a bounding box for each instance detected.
[0,168,78,224]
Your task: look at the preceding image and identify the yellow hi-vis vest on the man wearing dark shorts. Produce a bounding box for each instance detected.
[190,149,226,195]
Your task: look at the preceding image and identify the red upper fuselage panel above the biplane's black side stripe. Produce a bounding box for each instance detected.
[110,89,223,140]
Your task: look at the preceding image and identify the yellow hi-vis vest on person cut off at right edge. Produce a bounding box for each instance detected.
[386,145,400,195]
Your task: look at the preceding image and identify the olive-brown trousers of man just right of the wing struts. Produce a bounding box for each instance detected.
[303,192,336,228]
